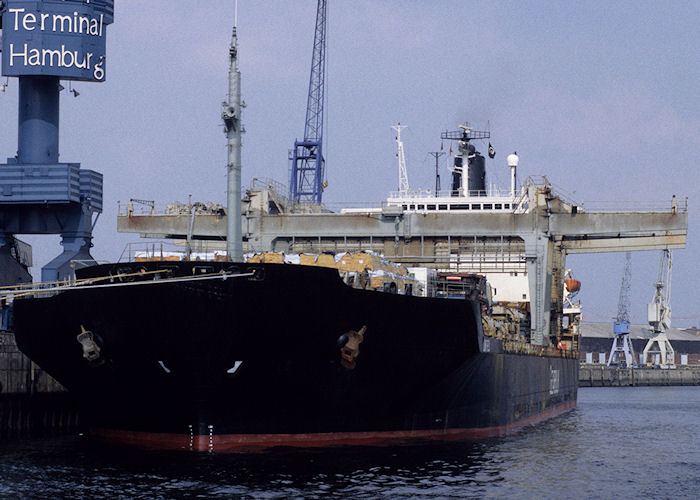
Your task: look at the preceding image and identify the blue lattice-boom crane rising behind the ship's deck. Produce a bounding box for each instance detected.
[289,0,327,204]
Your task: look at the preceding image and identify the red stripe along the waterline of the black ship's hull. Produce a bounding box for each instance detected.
[90,401,576,453]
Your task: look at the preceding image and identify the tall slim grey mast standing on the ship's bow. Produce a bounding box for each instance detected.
[226,21,243,262]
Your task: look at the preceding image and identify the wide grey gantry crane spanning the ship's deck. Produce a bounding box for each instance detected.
[117,177,688,346]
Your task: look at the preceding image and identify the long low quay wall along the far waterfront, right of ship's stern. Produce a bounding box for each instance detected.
[578,364,700,387]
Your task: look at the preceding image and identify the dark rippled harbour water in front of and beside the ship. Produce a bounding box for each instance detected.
[0,387,700,499]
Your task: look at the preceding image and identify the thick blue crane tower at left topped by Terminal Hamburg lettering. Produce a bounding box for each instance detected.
[0,0,114,285]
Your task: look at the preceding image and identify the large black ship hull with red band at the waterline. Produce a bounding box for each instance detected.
[14,262,578,452]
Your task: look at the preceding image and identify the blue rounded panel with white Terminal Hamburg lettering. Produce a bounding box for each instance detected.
[0,0,114,82]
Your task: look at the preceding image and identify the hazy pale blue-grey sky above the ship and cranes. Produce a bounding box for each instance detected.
[0,0,700,327]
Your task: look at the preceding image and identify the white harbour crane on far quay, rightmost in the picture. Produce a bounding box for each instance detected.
[643,249,676,368]
